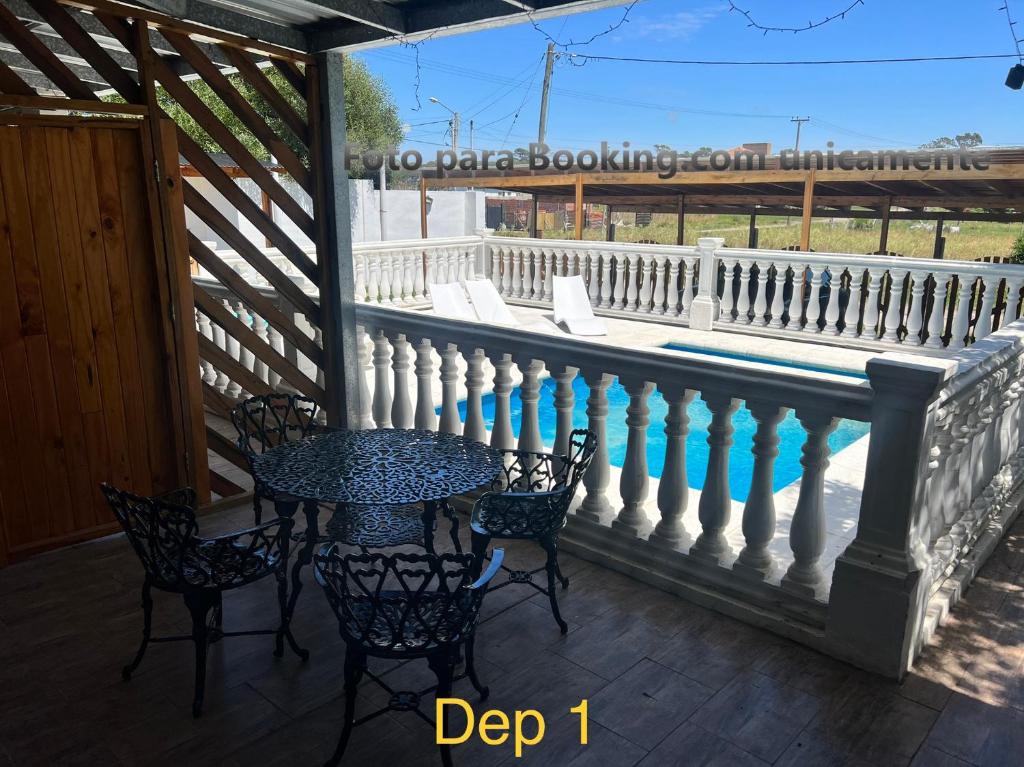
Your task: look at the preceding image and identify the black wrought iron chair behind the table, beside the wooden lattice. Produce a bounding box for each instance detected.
[231,393,460,550]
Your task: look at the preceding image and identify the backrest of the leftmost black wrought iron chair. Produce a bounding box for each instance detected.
[100,483,199,589]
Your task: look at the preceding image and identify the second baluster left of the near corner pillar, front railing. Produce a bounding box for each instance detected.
[732,402,786,580]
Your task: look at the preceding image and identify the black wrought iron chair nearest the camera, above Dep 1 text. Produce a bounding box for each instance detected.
[314,545,505,767]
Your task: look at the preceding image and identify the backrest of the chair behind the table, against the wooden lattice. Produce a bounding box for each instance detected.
[231,394,321,456]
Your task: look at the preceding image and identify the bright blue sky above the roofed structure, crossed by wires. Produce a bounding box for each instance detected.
[357,0,1024,155]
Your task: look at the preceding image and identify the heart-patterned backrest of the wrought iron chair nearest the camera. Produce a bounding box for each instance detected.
[314,544,497,656]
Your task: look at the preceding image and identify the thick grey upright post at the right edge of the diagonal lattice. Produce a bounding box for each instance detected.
[309,53,362,428]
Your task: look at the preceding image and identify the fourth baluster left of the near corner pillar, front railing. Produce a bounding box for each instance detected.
[650,384,696,549]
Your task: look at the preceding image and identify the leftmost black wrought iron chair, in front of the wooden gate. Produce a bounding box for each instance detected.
[101,484,291,717]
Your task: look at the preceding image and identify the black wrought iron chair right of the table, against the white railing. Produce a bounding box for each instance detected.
[470,429,597,634]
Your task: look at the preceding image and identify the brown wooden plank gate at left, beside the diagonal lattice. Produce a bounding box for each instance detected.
[0,117,208,565]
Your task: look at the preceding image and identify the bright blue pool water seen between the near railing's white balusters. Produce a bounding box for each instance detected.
[438,376,869,501]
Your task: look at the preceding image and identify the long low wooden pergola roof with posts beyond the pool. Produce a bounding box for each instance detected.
[420,150,1024,253]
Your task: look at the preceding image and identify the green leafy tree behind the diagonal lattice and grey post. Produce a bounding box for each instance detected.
[120,56,402,177]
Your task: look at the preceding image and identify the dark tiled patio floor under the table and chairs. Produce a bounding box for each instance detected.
[0,501,1024,767]
